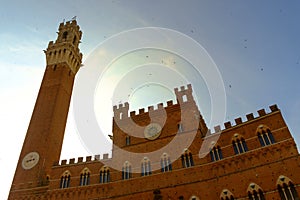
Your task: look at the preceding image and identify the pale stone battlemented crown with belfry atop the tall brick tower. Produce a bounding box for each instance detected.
[45,20,82,74]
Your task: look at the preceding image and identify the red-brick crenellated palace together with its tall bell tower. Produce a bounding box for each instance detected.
[9,21,300,200]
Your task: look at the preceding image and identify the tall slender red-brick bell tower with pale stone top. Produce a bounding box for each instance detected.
[9,20,82,199]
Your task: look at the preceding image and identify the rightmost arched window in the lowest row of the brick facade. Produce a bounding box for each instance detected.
[277,176,299,200]
